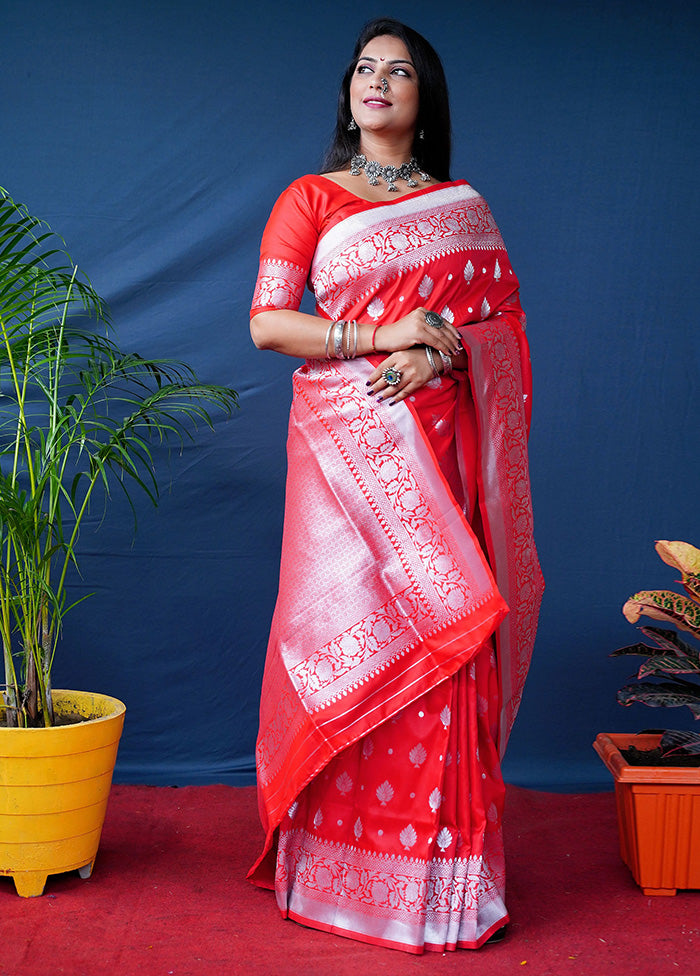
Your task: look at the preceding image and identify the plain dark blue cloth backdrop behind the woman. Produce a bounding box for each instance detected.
[0,0,700,789]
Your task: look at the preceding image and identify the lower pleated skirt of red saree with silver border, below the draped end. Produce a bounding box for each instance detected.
[275,646,508,952]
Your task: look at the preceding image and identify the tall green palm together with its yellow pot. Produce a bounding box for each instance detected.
[0,190,237,895]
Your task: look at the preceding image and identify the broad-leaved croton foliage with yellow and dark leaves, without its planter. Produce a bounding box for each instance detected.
[613,540,700,755]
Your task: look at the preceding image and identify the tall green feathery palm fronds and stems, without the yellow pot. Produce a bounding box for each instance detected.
[0,189,237,727]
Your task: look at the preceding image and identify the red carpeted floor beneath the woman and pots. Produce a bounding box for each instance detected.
[0,786,700,976]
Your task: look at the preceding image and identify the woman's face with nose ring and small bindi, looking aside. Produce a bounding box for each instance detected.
[350,35,420,141]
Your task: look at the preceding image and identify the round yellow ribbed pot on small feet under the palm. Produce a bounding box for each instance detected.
[0,691,126,897]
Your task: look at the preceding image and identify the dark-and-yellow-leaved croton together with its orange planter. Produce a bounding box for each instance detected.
[594,541,700,895]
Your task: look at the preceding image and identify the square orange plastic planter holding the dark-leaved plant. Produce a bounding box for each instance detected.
[593,733,700,895]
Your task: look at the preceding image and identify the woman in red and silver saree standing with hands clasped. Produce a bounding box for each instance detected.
[251,20,541,953]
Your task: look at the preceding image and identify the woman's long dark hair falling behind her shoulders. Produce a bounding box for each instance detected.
[321,17,452,182]
